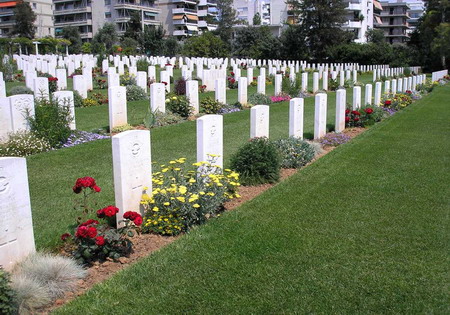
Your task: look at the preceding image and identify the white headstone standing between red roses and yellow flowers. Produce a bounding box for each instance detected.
[112,130,152,226]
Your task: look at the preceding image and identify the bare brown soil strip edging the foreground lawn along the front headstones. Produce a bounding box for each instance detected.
[39,127,366,314]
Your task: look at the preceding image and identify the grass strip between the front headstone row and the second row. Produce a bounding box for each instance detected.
[27,71,369,249]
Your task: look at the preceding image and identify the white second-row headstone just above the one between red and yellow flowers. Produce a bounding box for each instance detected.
[108,86,128,131]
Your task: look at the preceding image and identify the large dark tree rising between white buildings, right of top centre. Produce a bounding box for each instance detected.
[286,0,352,61]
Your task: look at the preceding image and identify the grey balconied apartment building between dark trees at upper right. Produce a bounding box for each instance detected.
[376,0,410,44]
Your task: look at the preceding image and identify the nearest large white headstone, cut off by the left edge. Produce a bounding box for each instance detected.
[0,157,35,270]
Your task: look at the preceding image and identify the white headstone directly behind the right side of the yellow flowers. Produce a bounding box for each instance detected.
[197,115,223,168]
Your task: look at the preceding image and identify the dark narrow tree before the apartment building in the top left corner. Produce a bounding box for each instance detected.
[11,0,36,39]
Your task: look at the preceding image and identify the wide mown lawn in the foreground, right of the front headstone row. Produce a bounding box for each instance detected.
[56,85,450,314]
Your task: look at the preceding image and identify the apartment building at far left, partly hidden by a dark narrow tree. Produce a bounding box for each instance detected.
[0,0,55,38]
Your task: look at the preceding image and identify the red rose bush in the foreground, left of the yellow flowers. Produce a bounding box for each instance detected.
[61,177,142,265]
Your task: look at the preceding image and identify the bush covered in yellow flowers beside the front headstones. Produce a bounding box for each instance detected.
[141,155,240,235]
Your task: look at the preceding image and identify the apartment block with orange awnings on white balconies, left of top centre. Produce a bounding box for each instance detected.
[159,0,218,39]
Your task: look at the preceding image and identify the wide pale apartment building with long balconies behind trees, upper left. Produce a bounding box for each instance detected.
[53,0,160,41]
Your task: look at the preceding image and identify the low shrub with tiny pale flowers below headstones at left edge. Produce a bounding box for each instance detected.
[0,131,52,157]
